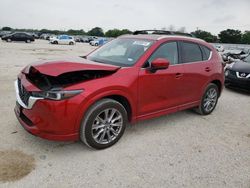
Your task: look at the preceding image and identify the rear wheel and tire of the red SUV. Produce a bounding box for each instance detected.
[195,83,219,115]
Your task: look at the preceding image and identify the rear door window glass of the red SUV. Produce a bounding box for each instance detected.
[181,42,202,63]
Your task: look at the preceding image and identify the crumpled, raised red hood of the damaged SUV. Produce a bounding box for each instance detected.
[22,57,120,76]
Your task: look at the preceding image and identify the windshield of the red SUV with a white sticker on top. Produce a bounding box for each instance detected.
[87,39,153,67]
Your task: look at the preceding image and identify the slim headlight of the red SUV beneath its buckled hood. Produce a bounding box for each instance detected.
[32,90,83,100]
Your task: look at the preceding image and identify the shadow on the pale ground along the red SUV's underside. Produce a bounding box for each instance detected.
[16,110,199,154]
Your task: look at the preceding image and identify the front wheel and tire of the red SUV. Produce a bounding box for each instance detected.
[80,99,128,149]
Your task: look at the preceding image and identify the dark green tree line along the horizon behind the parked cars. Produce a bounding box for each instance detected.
[2,27,250,44]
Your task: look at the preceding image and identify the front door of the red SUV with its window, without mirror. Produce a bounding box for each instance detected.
[138,42,183,118]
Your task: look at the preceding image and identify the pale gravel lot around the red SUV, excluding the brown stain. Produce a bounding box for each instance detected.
[0,40,250,188]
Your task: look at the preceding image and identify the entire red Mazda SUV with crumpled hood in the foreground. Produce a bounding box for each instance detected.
[15,34,224,149]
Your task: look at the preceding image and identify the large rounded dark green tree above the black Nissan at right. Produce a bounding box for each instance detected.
[218,29,242,44]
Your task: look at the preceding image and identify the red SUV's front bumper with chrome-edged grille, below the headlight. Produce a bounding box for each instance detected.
[14,78,80,141]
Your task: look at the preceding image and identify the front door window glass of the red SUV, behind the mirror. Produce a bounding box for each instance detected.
[148,42,178,65]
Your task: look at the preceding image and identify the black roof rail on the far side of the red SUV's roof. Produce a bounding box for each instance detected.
[133,30,194,37]
